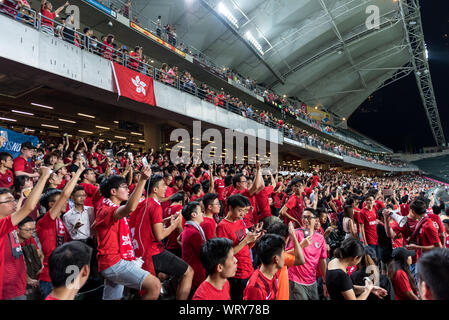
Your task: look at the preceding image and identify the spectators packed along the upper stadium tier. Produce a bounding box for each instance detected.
[0,0,403,166]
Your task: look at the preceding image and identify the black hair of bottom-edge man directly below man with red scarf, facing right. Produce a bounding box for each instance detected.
[200,238,232,275]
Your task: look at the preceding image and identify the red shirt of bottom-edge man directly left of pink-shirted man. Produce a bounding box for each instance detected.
[243,268,279,300]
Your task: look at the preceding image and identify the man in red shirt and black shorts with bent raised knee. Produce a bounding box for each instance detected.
[130,174,193,300]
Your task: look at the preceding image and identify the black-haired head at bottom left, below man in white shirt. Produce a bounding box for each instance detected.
[45,241,92,300]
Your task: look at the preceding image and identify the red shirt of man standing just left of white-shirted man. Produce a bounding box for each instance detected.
[36,209,71,282]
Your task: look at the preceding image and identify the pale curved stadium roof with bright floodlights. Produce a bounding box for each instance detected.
[133,0,413,119]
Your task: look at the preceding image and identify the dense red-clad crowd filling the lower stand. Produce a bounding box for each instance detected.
[0,136,449,300]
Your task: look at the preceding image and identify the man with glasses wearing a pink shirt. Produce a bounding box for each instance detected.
[286,208,328,300]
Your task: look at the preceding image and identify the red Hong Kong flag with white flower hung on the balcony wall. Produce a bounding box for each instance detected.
[112,62,156,106]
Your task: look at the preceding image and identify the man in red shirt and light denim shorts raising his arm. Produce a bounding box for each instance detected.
[95,167,161,300]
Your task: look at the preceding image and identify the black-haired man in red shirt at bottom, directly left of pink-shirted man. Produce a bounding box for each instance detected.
[243,234,285,300]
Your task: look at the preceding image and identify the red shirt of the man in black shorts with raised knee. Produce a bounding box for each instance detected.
[129,198,164,275]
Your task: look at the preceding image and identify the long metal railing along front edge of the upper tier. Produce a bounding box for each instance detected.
[0,3,412,169]
